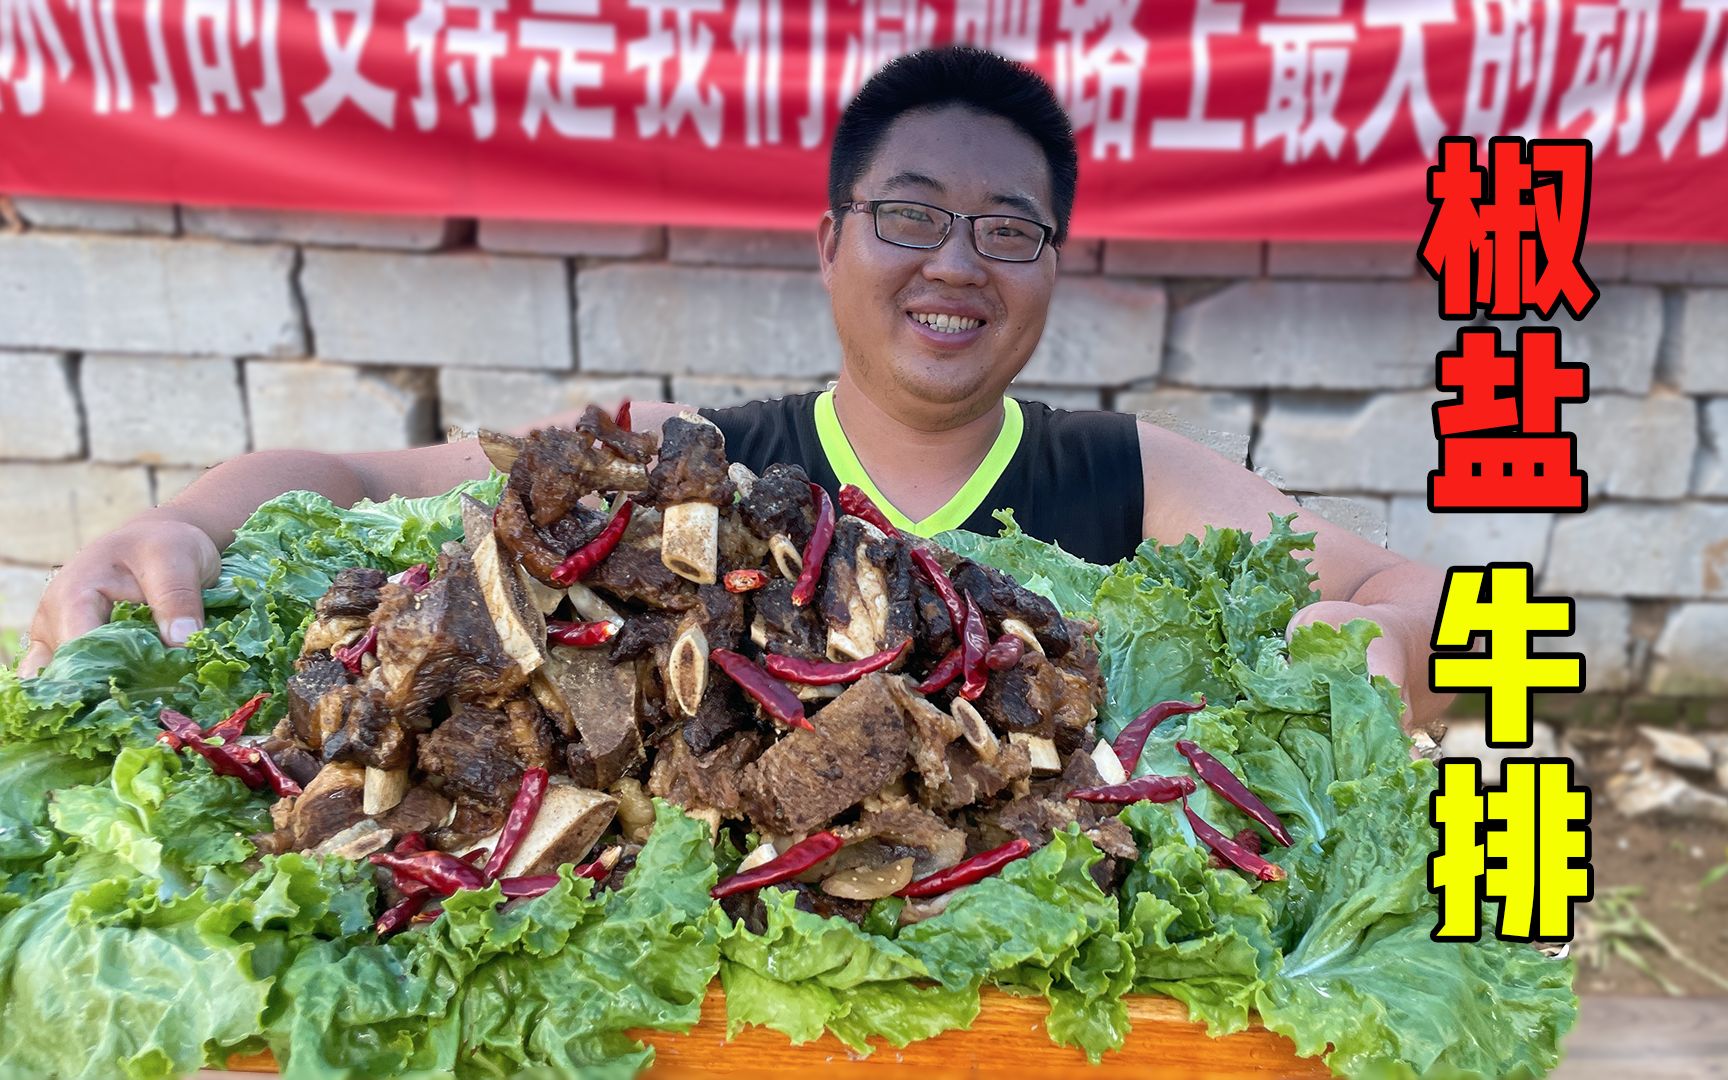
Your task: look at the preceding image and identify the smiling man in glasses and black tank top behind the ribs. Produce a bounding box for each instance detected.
[24,48,1441,724]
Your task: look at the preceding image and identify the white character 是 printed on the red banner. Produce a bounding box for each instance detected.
[517,0,619,138]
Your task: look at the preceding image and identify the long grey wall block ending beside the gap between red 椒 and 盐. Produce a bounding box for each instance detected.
[1165,280,1455,391]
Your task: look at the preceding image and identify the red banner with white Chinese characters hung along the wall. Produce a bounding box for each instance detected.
[0,0,1728,244]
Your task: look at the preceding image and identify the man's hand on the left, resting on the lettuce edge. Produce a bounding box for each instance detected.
[19,511,221,677]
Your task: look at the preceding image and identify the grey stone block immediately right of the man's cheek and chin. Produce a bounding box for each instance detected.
[1020,276,1168,387]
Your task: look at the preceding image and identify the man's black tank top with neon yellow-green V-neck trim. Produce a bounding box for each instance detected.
[698,391,1146,563]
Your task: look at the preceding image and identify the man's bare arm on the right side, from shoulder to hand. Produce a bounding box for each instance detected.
[1140,422,1452,731]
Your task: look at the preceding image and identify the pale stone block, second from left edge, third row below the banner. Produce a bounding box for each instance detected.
[78,354,247,465]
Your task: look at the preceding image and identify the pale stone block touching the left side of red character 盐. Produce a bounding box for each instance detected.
[1251,392,1438,494]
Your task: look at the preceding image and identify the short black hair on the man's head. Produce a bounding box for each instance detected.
[828,45,1080,247]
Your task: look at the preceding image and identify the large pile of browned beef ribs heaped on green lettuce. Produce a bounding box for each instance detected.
[261,408,1135,919]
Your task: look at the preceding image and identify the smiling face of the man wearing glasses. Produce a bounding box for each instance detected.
[821,105,1056,427]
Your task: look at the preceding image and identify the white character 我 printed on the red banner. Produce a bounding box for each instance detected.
[624,0,726,149]
